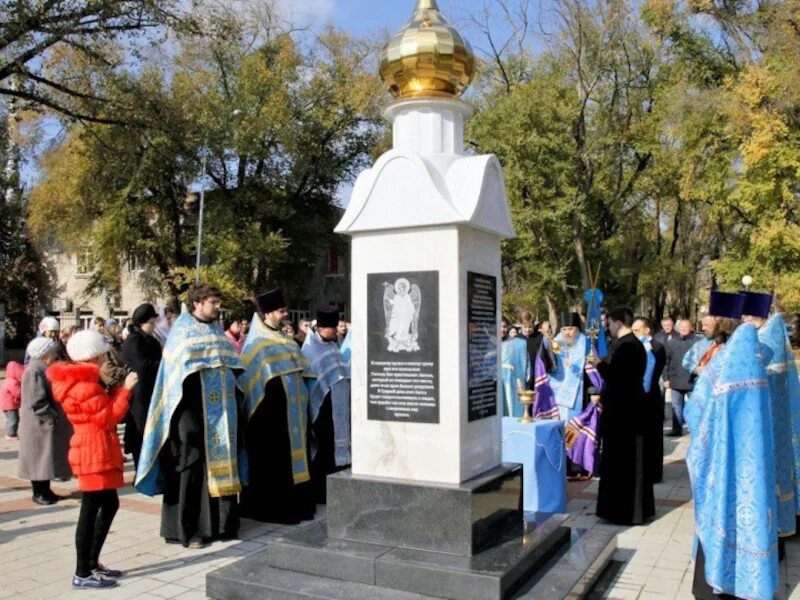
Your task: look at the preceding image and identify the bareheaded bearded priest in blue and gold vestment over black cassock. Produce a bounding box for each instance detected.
[135,283,246,548]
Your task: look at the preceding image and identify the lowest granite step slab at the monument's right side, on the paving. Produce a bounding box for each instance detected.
[514,526,620,600]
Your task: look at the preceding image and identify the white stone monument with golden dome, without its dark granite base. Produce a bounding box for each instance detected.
[336,0,514,484]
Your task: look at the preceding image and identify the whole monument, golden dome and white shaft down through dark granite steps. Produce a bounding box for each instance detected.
[206,0,615,600]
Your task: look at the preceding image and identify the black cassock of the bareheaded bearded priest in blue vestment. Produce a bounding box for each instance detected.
[159,373,239,546]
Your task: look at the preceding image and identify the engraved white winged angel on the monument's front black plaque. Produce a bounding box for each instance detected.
[383,277,422,352]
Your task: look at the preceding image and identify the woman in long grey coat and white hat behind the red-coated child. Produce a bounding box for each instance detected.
[19,337,72,505]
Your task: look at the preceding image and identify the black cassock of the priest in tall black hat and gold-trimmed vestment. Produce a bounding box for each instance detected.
[241,377,316,524]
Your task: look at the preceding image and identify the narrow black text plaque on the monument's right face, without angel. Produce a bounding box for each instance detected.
[467,272,498,421]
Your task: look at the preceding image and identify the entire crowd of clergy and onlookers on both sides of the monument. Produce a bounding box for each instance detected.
[0,284,800,600]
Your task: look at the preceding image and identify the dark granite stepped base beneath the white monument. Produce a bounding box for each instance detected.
[206,465,616,600]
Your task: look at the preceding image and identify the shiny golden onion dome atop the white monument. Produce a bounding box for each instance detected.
[380,0,475,98]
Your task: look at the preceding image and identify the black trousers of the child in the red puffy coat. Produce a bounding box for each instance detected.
[75,490,119,577]
